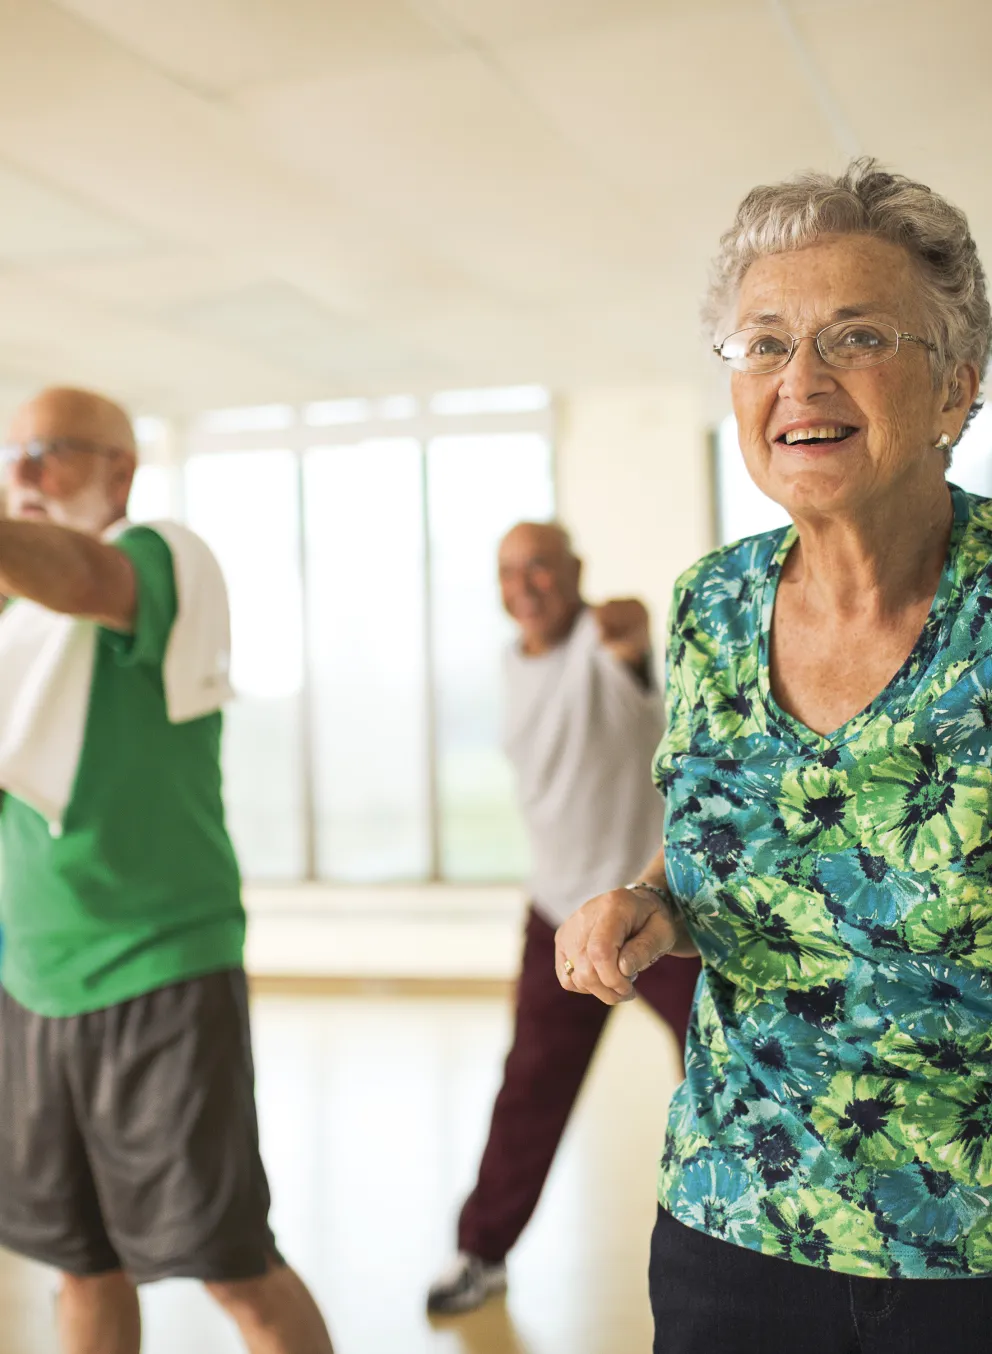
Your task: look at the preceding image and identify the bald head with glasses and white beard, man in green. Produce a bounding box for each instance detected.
[7,386,138,533]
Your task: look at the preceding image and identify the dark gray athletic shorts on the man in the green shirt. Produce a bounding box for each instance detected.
[0,969,280,1284]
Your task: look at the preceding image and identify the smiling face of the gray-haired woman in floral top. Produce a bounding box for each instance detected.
[728,236,968,517]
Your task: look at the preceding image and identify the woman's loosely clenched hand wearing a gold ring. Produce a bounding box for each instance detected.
[555,888,684,1006]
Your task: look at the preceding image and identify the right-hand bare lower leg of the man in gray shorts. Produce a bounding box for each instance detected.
[207,1265,334,1354]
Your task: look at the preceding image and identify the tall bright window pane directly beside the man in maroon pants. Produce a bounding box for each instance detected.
[428,433,554,881]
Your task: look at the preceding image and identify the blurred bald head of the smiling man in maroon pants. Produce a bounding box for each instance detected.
[499,521,582,654]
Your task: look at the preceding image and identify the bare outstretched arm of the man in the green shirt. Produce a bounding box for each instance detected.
[0,519,138,631]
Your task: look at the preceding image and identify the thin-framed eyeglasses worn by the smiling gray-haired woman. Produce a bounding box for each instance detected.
[713,320,937,376]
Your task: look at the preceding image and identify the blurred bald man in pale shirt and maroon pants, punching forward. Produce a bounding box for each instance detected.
[428,523,698,1313]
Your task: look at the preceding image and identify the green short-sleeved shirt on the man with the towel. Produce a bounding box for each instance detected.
[0,527,245,1016]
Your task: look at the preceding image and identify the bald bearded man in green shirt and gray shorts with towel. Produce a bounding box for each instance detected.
[0,390,330,1354]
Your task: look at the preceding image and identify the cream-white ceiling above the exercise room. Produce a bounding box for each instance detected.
[0,0,992,413]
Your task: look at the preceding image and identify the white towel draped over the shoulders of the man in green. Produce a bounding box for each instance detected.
[0,521,233,833]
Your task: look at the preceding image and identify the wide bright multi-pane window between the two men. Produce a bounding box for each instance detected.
[153,387,554,884]
